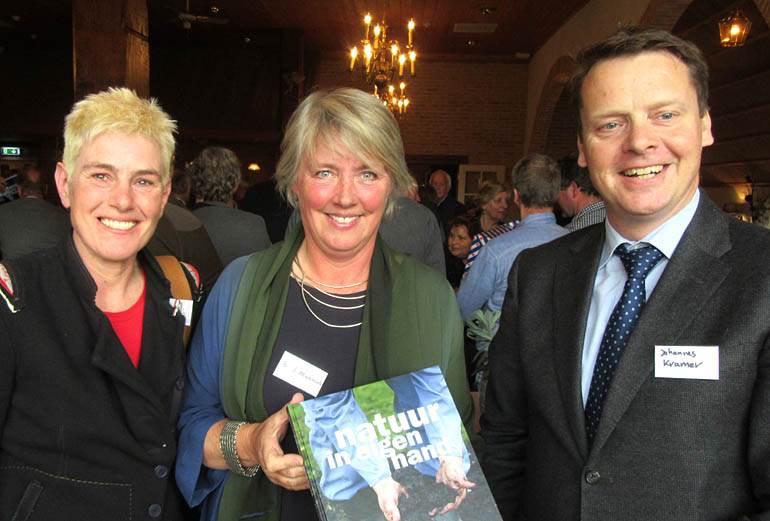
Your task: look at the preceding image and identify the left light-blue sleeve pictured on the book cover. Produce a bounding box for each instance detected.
[303,391,390,501]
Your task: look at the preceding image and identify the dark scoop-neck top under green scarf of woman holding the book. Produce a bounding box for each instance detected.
[263,280,366,521]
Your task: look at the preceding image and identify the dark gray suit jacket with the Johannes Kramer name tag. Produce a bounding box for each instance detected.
[482,194,770,521]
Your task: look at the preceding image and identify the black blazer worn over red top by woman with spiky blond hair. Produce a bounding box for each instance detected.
[0,238,184,521]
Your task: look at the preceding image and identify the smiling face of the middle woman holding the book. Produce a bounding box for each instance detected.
[292,138,391,262]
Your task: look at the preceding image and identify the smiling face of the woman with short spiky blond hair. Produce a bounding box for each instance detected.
[56,132,171,271]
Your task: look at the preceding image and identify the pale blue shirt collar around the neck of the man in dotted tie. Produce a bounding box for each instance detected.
[599,190,700,269]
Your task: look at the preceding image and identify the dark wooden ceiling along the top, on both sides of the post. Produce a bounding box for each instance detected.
[0,0,587,61]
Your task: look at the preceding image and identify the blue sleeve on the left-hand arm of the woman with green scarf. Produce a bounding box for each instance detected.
[176,257,248,506]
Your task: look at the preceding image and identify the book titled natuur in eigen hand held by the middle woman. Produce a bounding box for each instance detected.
[288,366,502,521]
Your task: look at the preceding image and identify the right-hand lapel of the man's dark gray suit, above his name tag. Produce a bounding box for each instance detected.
[592,193,731,451]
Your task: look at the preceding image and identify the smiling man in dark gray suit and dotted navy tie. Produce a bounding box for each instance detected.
[482,29,770,521]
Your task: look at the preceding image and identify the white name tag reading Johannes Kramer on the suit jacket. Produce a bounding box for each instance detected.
[655,346,719,380]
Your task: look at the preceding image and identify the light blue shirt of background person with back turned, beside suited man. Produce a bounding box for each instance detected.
[457,212,567,320]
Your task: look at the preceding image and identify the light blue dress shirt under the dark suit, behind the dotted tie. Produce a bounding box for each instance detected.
[581,190,700,405]
